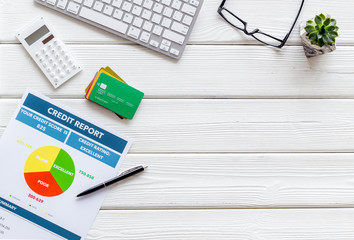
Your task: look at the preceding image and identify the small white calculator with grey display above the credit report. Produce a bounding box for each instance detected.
[17,17,82,88]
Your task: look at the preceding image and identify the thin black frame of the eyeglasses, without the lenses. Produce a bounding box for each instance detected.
[218,0,305,48]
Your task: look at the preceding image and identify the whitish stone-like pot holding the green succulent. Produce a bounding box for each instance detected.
[300,19,336,58]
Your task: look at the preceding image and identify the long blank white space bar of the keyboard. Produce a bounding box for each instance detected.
[79,7,128,34]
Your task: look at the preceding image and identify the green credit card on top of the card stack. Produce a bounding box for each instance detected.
[89,73,144,119]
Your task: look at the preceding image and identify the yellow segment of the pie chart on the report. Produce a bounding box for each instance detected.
[24,146,60,173]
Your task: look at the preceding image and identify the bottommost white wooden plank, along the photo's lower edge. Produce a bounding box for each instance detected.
[87,209,354,240]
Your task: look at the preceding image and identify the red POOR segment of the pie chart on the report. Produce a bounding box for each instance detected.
[25,172,63,197]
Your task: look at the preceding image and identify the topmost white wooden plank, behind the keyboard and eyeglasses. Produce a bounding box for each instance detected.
[0,0,354,44]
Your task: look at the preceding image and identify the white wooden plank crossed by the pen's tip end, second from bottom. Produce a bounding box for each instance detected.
[102,154,354,209]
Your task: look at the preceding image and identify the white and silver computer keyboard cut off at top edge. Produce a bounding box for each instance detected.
[35,0,203,59]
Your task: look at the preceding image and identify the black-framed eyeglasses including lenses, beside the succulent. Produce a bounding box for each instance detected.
[218,0,305,48]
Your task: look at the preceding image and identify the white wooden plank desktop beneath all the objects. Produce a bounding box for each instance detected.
[0,0,354,240]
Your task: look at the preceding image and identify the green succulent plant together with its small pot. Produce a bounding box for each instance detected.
[300,13,339,57]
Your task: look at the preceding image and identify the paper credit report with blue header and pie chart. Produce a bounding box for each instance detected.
[0,90,131,240]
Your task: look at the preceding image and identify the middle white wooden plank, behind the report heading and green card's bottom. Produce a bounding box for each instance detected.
[0,99,354,153]
